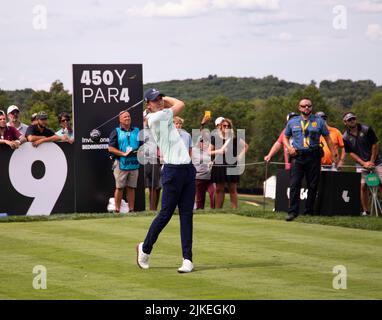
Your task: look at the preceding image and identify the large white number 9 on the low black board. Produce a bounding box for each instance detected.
[9,143,68,216]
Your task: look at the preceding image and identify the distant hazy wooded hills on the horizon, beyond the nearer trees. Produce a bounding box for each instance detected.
[0,75,382,110]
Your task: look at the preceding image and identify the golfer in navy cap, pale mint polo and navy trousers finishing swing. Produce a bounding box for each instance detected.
[136,88,196,273]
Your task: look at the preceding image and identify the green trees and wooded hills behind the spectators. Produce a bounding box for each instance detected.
[0,75,382,189]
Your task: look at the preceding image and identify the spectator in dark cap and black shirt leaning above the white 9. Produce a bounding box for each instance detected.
[25,111,63,147]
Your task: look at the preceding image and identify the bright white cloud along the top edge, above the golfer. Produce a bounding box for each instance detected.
[126,0,280,18]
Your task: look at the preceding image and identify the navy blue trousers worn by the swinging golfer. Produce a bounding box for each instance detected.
[142,164,196,261]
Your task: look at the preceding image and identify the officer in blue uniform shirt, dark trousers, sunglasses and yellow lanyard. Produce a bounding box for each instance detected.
[283,98,338,221]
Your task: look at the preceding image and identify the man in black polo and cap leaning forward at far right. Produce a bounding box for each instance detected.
[343,112,382,216]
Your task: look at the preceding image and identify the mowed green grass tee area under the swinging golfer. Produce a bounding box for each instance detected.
[0,214,382,300]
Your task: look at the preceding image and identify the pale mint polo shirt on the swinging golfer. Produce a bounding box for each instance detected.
[148,109,191,164]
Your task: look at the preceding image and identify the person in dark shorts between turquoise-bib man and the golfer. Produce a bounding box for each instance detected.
[143,112,162,211]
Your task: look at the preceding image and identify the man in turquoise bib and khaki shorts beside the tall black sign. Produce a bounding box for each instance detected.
[108,111,139,213]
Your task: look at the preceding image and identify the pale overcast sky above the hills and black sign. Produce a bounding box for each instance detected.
[0,0,382,91]
